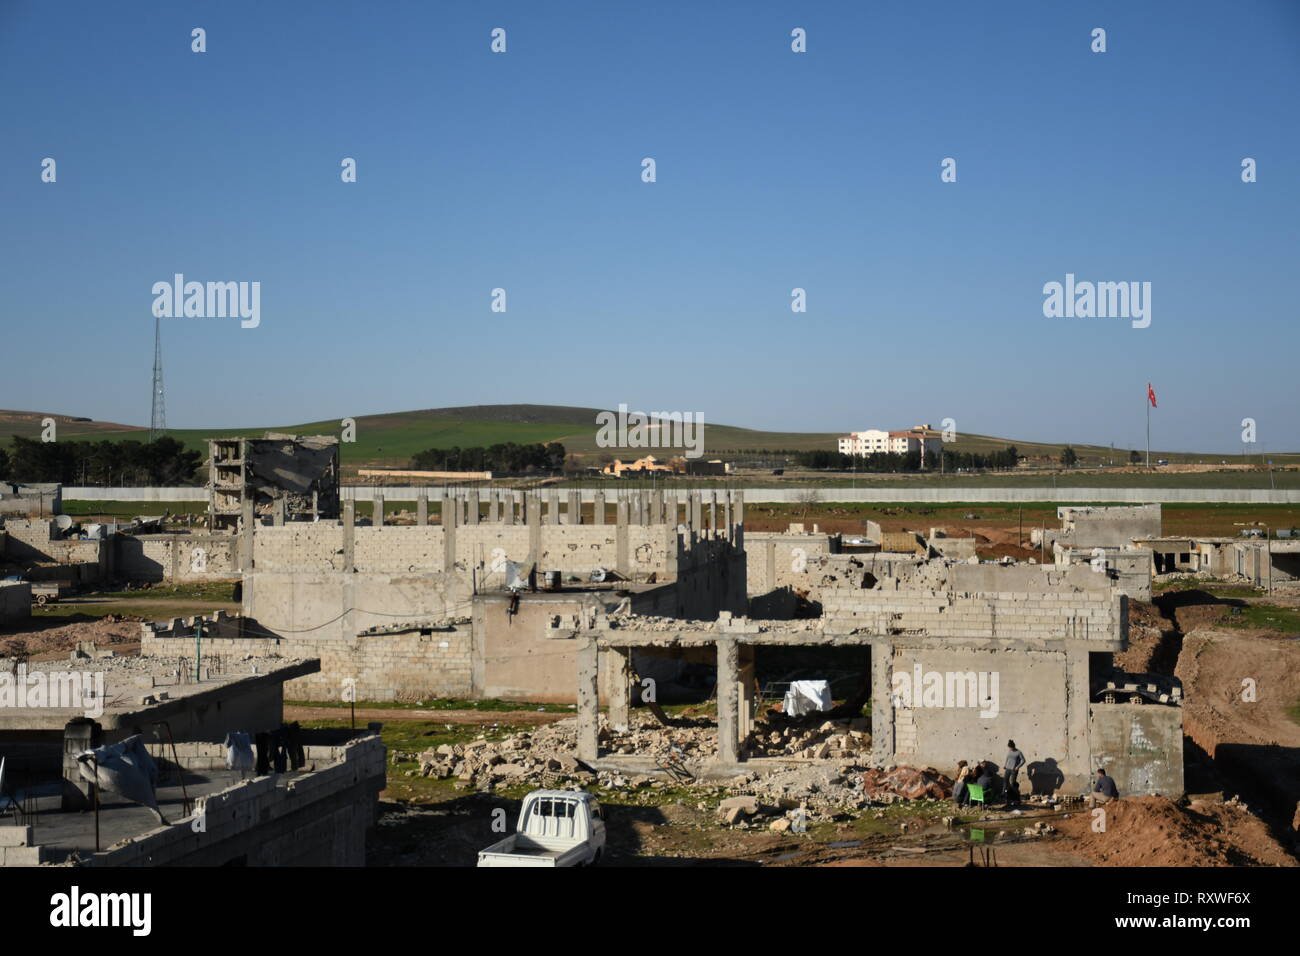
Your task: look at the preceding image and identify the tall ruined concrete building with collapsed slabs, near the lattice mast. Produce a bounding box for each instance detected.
[208,433,339,531]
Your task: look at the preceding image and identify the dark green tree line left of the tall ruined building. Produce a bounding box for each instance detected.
[0,434,203,485]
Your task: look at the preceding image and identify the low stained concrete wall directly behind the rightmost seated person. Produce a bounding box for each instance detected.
[1088,704,1183,800]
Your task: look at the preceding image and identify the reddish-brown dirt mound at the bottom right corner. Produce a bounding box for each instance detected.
[1058,796,1297,866]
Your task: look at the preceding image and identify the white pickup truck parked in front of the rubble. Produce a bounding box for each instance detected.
[478,790,605,866]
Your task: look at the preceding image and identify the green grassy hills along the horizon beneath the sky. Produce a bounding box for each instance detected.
[0,405,1300,467]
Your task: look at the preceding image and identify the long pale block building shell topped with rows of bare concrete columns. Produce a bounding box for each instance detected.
[234,492,745,700]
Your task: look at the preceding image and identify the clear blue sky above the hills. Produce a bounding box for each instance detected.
[0,0,1300,451]
